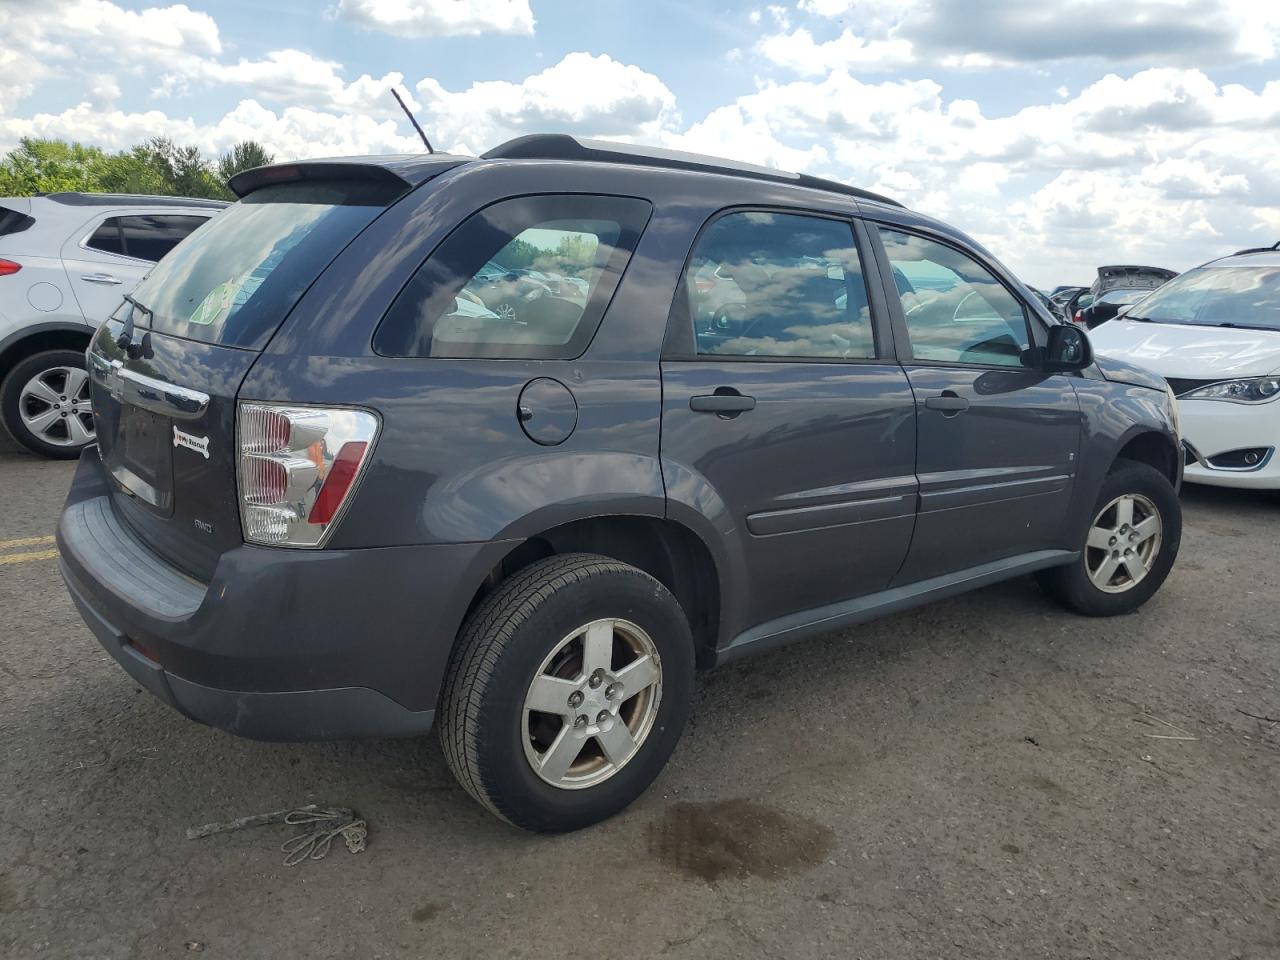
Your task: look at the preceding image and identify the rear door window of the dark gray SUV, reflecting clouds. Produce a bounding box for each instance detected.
[685,211,876,360]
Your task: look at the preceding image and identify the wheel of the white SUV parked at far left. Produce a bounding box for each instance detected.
[0,349,96,460]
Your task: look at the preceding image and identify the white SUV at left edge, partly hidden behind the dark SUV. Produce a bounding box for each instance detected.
[0,193,227,458]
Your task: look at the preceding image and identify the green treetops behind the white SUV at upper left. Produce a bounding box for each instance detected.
[0,137,271,200]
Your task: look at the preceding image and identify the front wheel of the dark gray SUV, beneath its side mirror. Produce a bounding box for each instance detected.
[1037,460,1183,617]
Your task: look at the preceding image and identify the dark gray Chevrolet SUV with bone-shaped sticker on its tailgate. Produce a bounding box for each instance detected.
[58,136,1183,831]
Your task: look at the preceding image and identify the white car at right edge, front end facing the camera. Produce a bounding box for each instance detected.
[1089,244,1280,489]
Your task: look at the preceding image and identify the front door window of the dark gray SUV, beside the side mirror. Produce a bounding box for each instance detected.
[879,229,1030,366]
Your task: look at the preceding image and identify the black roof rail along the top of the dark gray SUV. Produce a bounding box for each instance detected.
[481,133,902,206]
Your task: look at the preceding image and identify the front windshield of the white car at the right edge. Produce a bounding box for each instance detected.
[1128,265,1280,330]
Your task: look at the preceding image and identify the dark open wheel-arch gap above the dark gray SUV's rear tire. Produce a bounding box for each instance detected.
[463,515,721,666]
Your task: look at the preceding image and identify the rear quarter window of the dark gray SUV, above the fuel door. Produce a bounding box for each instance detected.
[374,195,650,360]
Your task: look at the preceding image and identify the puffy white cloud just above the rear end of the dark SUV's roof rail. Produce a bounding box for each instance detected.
[416,52,677,152]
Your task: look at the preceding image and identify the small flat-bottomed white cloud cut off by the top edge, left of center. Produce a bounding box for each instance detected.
[334,0,534,37]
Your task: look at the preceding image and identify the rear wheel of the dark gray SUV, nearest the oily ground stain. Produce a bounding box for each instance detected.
[439,553,694,833]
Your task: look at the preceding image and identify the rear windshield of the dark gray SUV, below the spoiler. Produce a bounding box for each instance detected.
[133,180,396,349]
